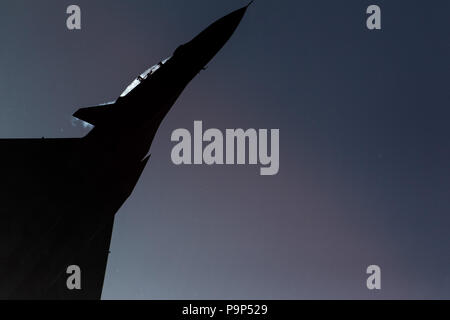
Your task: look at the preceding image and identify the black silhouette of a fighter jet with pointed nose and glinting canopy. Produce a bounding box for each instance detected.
[0,6,248,299]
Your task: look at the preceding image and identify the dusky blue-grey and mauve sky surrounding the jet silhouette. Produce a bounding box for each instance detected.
[0,0,450,299]
